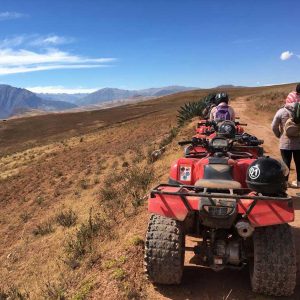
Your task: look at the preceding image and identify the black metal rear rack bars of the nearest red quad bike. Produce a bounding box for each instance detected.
[150,184,292,217]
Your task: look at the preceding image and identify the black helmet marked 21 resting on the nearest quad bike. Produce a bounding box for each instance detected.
[246,157,289,195]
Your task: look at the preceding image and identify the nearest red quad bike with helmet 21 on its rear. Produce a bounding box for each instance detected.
[144,137,296,296]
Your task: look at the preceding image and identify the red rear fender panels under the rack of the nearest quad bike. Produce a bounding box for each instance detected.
[148,184,294,227]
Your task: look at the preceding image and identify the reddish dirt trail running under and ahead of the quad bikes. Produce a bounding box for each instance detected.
[150,97,300,300]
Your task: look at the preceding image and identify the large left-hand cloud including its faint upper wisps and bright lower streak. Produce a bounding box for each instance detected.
[0,34,116,75]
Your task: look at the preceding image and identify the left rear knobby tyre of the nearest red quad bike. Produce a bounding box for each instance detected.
[144,215,185,284]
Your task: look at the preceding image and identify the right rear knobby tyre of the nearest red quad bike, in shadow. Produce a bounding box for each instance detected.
[250,224,296,296]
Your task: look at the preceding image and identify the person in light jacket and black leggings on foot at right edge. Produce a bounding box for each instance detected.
[272,84,300,188]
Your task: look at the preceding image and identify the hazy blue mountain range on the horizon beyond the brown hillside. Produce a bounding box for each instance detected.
[0,84,244,118]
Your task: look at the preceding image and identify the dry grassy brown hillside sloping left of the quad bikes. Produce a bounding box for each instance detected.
[0,86,298,299]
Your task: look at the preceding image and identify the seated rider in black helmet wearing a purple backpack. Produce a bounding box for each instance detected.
[209,92,235,121]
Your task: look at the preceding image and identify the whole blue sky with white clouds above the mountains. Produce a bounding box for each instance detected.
[0,0,300,92]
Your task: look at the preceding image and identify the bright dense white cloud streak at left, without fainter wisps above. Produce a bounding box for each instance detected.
[0,48,115,75]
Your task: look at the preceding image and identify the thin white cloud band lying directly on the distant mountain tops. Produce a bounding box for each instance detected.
[26,85,100,94]
